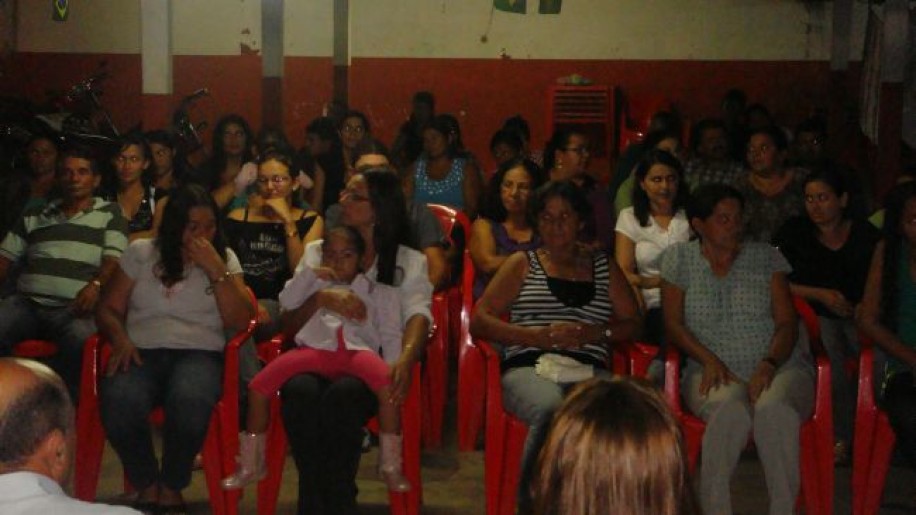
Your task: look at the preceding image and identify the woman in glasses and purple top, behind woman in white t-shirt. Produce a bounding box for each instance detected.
[544,128,614,254]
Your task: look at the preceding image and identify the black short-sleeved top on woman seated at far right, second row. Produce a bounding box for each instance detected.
[773,216,881,318]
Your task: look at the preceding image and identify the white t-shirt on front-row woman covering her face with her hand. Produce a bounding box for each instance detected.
[120,239,242,352]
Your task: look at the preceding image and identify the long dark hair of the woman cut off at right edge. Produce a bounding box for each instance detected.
[881,181,916,331]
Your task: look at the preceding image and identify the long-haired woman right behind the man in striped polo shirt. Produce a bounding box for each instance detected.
[102,133,161,241]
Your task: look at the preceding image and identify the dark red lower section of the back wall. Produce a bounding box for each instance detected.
[0,53,859,177]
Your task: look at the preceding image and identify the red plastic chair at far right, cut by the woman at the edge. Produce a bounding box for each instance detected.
[852,335,897,515]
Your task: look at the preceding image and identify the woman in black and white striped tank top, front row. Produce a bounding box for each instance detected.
[471,181,641,513]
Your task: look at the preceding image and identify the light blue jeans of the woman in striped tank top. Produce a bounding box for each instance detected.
[502,367,610,512]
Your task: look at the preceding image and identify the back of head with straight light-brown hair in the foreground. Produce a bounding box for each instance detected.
[532,378,693,515]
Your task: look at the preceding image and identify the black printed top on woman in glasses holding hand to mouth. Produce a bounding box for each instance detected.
[224,207,318,299]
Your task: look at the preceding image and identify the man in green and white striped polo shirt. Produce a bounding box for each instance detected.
[0,148,127,400]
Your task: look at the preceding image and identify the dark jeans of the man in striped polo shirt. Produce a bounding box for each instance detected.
[0,294,95,402]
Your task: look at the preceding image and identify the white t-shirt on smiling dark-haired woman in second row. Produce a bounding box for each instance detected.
[615,207,690,309]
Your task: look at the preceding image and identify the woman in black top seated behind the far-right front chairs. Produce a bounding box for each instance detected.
[773,169,880,462]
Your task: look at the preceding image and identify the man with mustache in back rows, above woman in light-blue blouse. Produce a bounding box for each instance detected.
[684,118,742,190]
